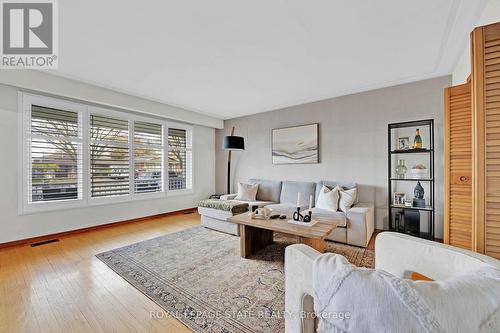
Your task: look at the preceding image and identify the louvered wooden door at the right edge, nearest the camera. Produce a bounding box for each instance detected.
[472,23,500,258]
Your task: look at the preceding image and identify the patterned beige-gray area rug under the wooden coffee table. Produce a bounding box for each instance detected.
[97,227,374,332]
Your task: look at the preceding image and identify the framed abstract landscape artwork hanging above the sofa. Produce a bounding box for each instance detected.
[272,124,319,164]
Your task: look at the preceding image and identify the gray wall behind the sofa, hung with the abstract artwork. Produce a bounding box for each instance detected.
[215,76,451,238]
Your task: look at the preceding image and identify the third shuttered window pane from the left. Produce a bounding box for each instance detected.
[134,121,163,193]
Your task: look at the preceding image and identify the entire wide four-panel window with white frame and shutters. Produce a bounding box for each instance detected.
[20,94,193,213]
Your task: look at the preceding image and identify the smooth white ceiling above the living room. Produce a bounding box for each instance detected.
[56,0,485,119]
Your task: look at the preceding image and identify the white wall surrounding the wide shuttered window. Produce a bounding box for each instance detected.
[0,83,215,243]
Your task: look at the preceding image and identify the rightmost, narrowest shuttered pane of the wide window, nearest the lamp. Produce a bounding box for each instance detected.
[168,128,192,191]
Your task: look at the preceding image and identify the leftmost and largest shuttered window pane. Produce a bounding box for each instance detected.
[28,105,82,203]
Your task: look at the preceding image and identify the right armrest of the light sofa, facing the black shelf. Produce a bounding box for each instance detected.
[346,202,375,247]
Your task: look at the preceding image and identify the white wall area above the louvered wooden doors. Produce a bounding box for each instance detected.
[452,0,500,85]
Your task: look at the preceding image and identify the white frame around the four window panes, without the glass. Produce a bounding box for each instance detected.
[18,92,194,215]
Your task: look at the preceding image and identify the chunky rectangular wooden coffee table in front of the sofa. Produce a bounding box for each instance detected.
[227,213,337,258]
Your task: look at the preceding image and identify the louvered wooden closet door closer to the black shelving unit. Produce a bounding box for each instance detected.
[444,83,473,250]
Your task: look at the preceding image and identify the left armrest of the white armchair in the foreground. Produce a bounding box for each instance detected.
[285,244,320,333]
